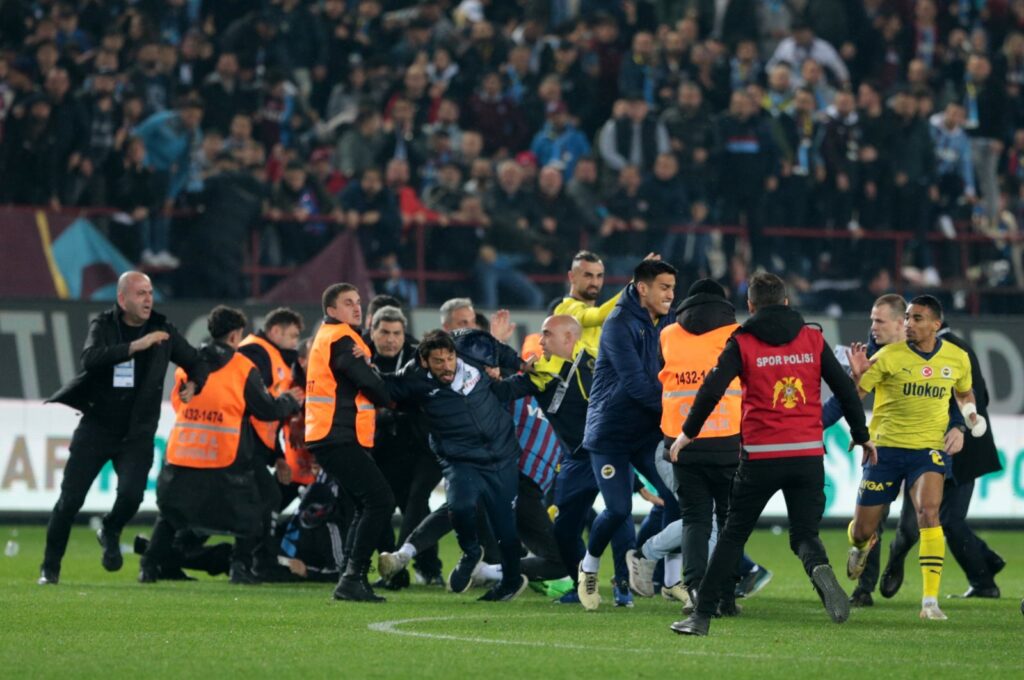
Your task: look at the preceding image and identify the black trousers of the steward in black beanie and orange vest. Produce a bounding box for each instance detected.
[673,464,737,588]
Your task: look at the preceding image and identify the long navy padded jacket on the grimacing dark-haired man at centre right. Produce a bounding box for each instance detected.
[583,284,676,454]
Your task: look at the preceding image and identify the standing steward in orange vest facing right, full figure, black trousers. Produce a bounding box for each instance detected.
[306,284,394,602]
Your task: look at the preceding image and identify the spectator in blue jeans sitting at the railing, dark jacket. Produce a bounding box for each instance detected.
[475,160,544,309]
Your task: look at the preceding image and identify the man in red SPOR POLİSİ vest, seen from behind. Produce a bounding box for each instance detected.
[667,272,877,635]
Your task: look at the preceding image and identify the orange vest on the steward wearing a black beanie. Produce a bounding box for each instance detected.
[657,324,742,437]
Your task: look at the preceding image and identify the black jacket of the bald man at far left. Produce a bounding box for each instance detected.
[47,305,209,445]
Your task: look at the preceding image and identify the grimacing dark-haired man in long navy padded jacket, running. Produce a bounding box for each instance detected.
[578,260,676,609]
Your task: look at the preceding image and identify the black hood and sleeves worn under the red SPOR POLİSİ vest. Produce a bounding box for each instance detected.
[683,305,870,454]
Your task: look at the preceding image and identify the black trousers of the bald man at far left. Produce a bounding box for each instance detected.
[43,418,153,571]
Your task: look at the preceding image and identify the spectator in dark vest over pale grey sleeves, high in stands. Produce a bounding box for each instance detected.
[598,91,672,175]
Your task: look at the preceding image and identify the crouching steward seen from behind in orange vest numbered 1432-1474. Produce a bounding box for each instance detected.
[138,305,301,584]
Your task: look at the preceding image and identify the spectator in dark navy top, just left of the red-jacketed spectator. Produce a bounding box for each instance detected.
[341,168,401,266]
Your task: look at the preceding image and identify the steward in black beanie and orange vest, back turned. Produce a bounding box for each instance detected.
[658,279,742,612]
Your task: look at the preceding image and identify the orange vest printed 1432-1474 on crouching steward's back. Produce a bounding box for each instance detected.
[167,352,256,468]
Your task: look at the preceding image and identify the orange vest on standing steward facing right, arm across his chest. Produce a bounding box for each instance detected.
[306,324,377,449]
